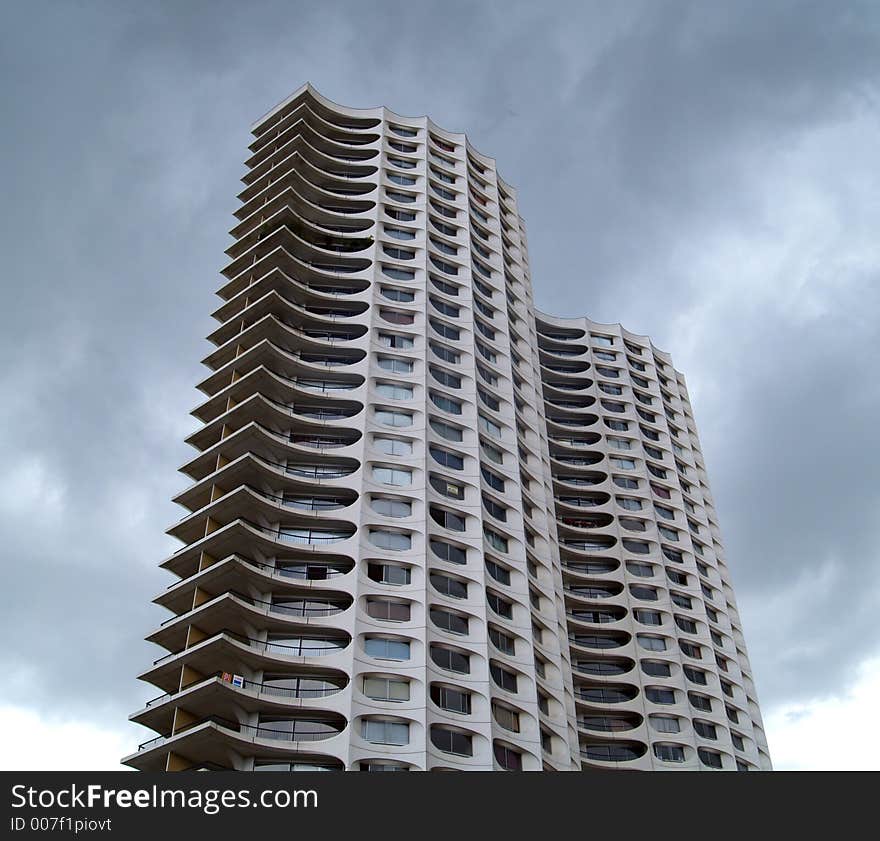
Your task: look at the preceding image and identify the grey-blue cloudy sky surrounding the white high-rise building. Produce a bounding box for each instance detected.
[0,0,880,768]
